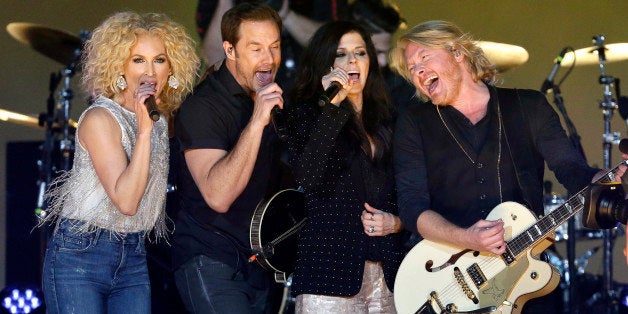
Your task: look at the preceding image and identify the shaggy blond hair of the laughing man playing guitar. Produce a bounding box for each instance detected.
[388,21,497,98]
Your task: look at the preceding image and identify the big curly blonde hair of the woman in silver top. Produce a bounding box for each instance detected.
[82,12,200,117]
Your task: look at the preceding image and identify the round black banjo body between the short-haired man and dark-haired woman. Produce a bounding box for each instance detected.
[249,189,305,283]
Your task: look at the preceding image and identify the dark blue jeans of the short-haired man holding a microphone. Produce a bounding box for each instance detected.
[174,255,269,314]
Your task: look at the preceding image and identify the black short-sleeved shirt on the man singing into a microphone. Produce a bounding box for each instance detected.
[173,64,277,276]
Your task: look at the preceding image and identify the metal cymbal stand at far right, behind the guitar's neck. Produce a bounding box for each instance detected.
[586,35,621,313]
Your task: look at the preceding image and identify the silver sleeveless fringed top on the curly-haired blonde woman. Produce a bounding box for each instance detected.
[41,96,170,238]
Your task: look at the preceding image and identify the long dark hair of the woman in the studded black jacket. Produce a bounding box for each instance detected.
[289,21,392,160]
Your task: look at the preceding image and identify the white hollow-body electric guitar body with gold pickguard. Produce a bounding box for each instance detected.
[394,202,560,314]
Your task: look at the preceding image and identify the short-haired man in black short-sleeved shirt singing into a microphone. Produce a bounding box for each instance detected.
[173,2,283,313]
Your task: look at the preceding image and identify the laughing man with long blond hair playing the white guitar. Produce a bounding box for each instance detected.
[390,21,625,313]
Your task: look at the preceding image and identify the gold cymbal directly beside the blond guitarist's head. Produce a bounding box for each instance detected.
[475,41,529,73]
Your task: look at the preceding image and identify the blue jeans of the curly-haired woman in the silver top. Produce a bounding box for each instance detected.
[43,219,151,313]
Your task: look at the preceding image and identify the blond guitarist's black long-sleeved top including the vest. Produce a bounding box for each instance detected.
[393,86,597,233]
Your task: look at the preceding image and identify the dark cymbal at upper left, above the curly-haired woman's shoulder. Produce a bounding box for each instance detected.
[7,23,82,65]
